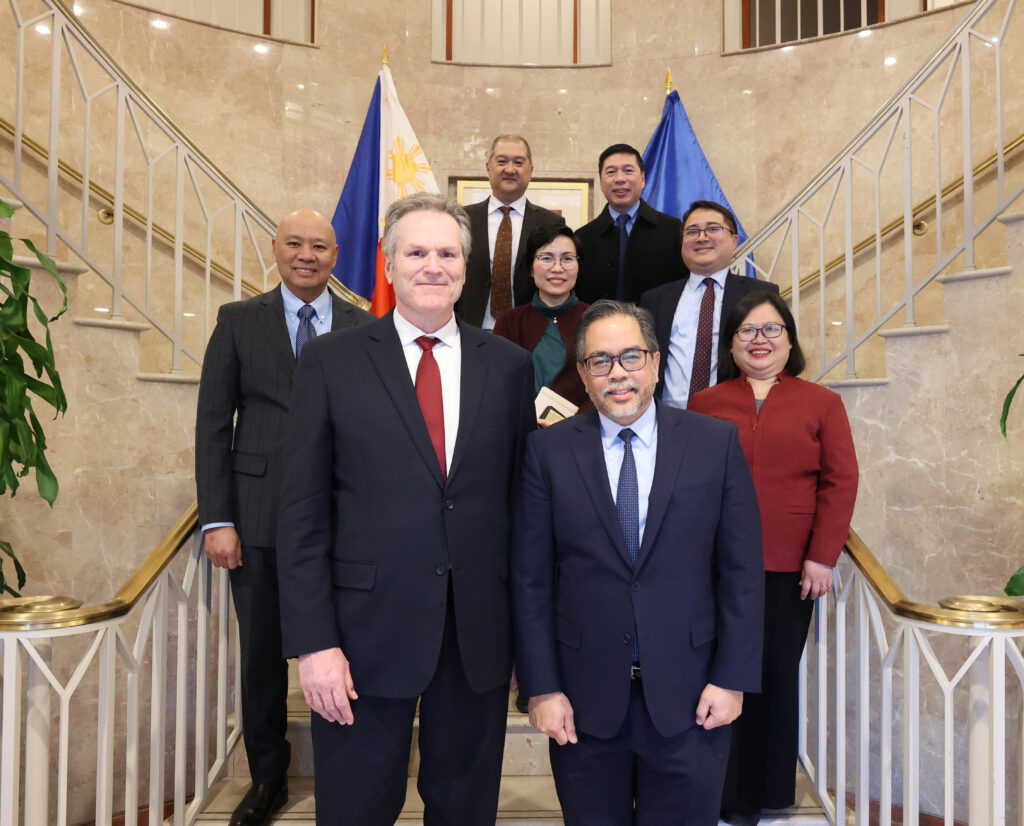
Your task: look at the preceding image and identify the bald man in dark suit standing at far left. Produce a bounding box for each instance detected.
[196,210,374,826]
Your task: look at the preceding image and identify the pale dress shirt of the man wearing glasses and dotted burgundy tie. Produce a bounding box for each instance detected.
[662,267,729,407]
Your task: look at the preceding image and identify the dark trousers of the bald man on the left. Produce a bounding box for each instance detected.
[230,548,292,783]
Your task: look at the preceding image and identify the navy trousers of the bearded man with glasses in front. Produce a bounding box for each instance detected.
[549,683,729,826]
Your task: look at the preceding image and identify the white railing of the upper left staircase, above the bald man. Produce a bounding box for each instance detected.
[0,0,286,373]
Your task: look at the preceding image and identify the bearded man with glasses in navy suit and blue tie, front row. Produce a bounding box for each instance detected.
[512,301,764,826]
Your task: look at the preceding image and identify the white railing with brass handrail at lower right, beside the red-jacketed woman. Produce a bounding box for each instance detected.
[800,531,1024,826]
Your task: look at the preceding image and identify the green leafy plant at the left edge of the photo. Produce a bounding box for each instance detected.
[0,200,68,597]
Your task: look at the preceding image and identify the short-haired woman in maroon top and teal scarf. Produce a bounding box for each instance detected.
[495,224,592,409]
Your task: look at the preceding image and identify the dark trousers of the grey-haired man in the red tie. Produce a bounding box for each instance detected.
[311,591,509,826]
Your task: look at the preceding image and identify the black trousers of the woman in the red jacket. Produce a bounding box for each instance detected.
[722,571,814,813]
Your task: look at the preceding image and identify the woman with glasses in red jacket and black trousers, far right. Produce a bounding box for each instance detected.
[688,291,858,826]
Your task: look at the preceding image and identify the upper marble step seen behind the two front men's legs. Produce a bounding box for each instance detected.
[227,689,551,778]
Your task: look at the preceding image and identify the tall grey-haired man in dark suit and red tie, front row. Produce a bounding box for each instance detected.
[278,193,535,826]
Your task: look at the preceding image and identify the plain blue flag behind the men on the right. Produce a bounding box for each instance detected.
[643,92,753,274]
